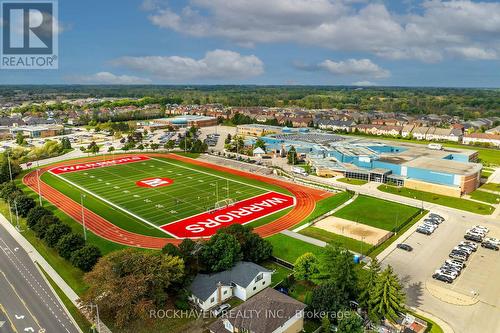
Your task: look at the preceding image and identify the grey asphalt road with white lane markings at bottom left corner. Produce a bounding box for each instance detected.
[0,220,80,333]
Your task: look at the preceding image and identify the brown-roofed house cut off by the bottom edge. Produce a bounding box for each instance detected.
[208,288,306,333]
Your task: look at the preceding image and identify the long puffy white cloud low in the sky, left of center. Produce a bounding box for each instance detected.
[112,50,264,82]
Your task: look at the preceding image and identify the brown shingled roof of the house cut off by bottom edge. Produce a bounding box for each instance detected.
[209,288,306,333]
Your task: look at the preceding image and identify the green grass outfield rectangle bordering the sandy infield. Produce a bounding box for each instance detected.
[333,195,419,231]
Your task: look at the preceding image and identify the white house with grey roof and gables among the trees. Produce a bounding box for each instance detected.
[190,261,273,311]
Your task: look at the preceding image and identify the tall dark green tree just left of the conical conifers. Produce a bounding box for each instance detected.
[319,244,357,297]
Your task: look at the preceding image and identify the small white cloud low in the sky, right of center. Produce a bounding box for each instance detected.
[318,59,390,79]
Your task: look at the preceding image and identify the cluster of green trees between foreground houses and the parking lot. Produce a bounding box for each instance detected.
[293,244,405,332]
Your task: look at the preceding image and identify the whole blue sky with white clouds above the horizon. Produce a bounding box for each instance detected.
[0,0,500,87]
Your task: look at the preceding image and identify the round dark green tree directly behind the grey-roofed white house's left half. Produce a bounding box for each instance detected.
[201,233,243,272]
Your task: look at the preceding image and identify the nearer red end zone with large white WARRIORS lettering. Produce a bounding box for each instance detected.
[161,192,296,239]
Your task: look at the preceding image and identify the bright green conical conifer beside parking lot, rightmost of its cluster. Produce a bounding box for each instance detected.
[370,266,406,322]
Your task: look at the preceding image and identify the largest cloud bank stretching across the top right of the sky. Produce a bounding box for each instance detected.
[145,0,500,62]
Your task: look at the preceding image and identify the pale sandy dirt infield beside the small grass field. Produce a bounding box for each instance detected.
[314,216,392,245]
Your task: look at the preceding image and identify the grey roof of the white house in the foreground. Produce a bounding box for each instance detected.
[190,261,271,300]
